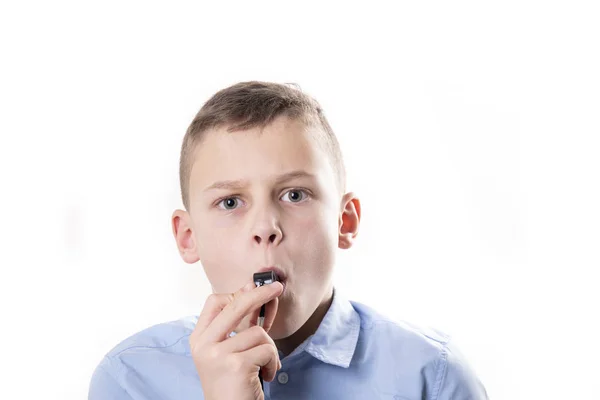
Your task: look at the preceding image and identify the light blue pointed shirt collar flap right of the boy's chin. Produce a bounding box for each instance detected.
[290,287,360,368]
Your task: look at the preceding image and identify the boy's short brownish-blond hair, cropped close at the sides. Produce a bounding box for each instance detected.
[179,81,346,210]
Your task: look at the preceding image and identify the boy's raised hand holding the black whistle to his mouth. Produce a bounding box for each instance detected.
[190,282,283,400]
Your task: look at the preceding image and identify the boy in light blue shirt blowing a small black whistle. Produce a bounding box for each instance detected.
[89,82,487,400]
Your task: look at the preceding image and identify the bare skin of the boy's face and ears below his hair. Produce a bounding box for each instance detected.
[172,117,361,355]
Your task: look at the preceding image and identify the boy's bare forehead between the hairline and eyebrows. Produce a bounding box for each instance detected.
[190,117,335,193]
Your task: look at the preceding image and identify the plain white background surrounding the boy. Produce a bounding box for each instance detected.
[0,1,600,400]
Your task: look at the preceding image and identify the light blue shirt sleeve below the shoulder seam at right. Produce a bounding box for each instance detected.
[432,343,488,400]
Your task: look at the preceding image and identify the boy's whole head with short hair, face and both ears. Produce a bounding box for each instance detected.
[172,82,360,339]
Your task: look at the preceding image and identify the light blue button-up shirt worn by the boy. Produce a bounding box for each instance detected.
[89,289,488,400]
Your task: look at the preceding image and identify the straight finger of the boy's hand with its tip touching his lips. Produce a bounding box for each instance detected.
[204,282,283,342]
